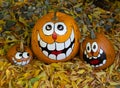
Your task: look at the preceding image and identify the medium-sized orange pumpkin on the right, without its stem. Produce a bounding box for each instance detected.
[80,33,115,70]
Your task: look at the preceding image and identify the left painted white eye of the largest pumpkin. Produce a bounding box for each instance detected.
[43,22,54,35]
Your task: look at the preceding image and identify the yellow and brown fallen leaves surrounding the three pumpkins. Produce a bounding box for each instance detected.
[0,0,120,88]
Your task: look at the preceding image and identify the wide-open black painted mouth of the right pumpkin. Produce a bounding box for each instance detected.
[83,49,106,67]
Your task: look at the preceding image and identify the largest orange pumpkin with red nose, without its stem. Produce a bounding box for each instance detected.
[31,12,81,63]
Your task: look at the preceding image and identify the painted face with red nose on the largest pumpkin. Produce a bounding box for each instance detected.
[38,22,75,60]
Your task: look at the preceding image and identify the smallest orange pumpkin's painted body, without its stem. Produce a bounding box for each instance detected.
[7,44,33,66]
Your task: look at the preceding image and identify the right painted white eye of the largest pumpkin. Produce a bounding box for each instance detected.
[55,22,67,35]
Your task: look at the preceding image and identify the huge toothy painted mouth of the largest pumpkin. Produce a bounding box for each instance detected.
[38,30,75,60]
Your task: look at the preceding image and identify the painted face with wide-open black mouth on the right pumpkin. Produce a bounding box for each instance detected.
[83,42,106,67]
